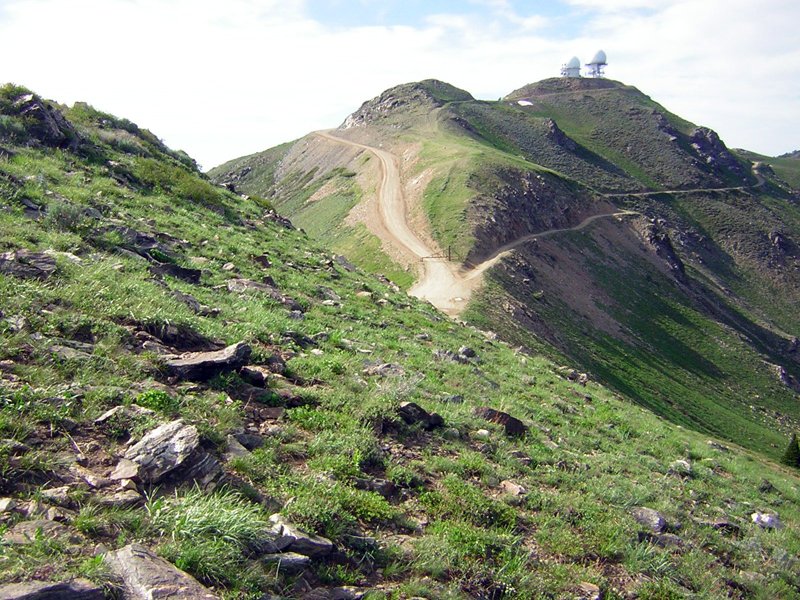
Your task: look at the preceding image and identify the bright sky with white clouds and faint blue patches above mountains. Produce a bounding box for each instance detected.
[0,0,800,169]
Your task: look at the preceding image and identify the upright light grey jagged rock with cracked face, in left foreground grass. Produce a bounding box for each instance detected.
[125,419,200,483]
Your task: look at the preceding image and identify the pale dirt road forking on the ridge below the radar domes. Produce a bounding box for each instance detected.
[316,131,636,316]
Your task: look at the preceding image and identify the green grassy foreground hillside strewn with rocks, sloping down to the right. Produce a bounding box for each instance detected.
[0,86,800,598]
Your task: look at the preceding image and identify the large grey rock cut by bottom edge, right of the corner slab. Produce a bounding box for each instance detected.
[105,544,219,600]
